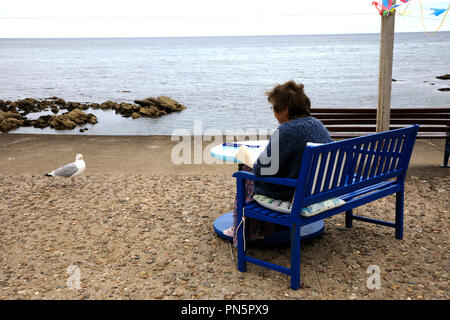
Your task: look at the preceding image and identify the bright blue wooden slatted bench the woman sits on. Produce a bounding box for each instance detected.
[233,125,419,290]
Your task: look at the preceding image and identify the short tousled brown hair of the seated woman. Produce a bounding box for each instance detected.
[266,80,311,119]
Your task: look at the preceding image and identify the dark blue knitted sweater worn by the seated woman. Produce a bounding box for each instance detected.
[253,117,333,201]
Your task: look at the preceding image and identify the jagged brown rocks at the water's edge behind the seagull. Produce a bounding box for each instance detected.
[0,96,186,132]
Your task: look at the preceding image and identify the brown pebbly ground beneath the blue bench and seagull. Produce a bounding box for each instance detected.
[0,135,450,300]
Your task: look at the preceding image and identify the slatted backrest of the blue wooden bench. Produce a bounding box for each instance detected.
[292,125,418,212]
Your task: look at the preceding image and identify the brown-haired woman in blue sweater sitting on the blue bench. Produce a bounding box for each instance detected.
[224,80,333,244]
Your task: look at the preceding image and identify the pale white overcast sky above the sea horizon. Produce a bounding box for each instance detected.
[0,0,450,38]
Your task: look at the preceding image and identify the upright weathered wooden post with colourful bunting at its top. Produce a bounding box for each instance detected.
[377,0,395,132]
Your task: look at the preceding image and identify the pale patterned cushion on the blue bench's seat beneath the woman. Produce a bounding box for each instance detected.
[253,194,345,217]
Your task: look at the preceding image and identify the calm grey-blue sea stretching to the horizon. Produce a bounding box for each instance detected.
[0,32,450,135]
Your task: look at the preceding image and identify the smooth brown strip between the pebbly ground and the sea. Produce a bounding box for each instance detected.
[0,133,449,177]
